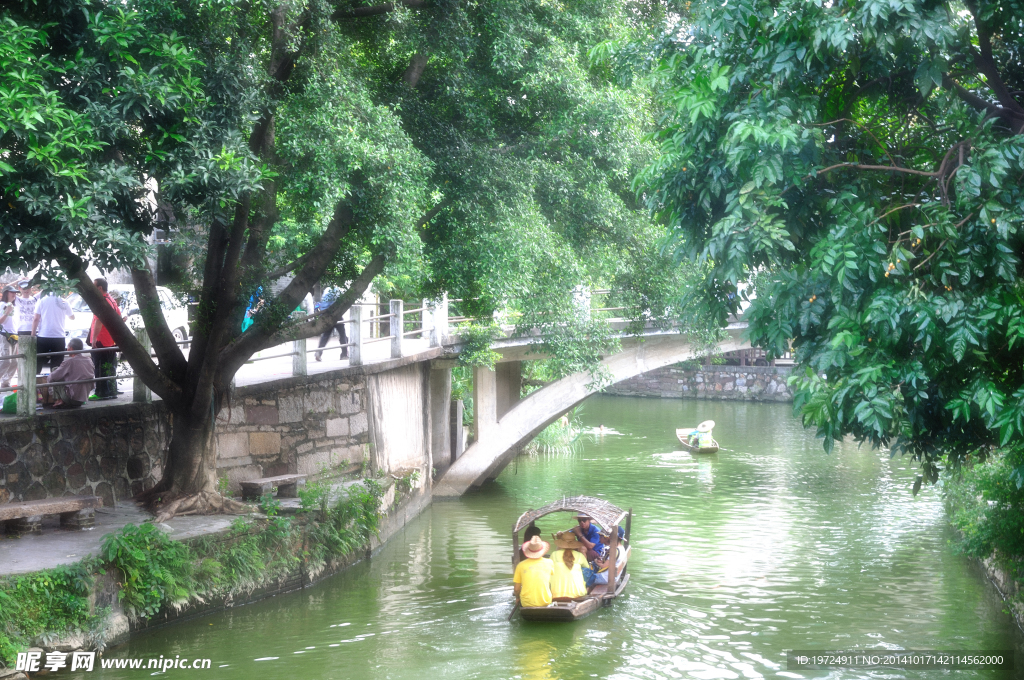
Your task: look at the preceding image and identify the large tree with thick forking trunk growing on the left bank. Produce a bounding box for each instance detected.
[0,0,676,511]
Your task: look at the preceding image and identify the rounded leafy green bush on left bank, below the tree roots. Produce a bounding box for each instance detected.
[99,522,195,617]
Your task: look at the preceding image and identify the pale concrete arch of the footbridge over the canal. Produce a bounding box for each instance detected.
[433,324,751,498]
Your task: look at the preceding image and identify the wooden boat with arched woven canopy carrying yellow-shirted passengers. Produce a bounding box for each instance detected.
[512,496,633,622]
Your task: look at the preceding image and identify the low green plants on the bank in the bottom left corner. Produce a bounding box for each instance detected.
[0,563,95,666]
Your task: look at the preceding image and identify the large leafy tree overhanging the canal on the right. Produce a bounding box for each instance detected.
[638,0,1024,479]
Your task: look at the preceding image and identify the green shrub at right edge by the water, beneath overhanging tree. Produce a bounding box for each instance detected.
[945,445,1024,579]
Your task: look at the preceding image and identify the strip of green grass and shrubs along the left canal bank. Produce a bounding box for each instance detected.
[0,479,383,667]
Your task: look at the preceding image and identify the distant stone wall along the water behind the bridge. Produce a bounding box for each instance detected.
[604,365,793,401]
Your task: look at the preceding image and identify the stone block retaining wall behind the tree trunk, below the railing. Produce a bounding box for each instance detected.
[0,357,430,507]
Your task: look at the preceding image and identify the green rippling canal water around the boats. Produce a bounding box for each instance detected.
[94,396,1024,680]
